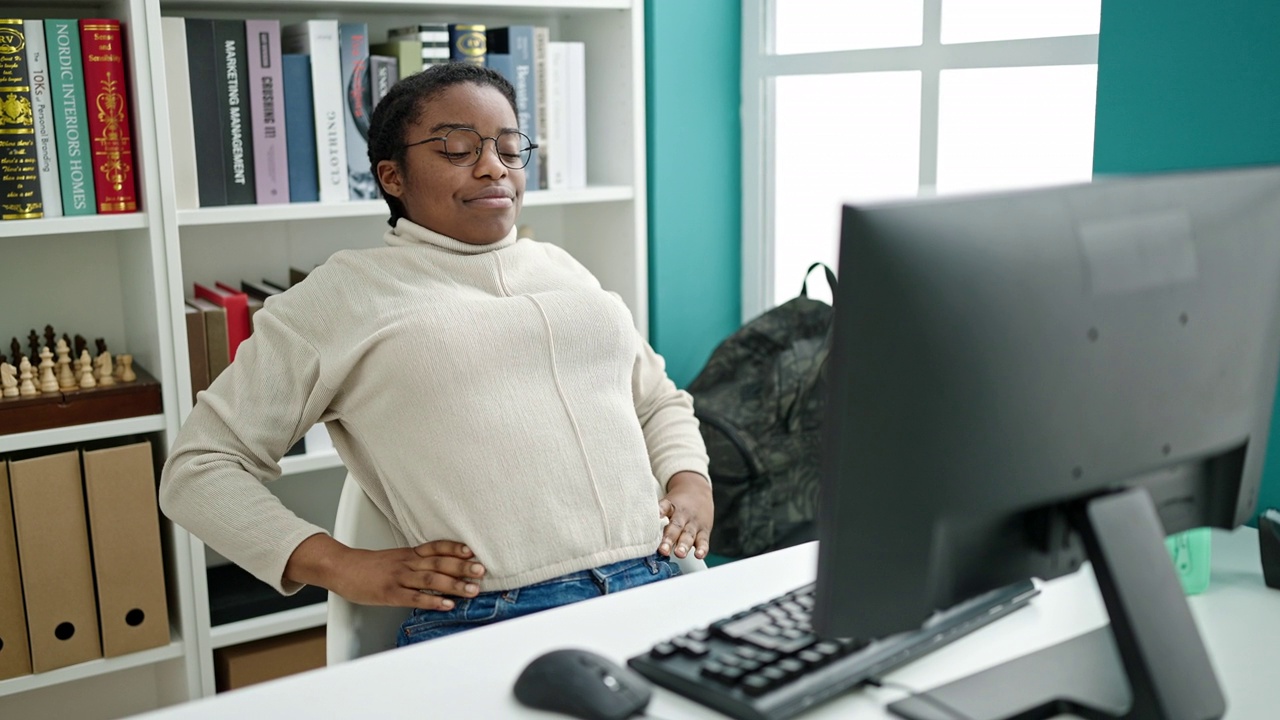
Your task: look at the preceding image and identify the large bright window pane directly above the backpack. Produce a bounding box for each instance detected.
[773,72,920,302]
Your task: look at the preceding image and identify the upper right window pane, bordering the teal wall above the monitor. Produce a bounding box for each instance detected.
[942,0,1102,44]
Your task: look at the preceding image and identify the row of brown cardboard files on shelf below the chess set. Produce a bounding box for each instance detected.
[0,438,169,680]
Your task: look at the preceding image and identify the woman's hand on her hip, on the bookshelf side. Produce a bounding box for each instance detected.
[284,534,485,610]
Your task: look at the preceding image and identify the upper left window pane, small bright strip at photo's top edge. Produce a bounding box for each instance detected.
[772,0,924,55]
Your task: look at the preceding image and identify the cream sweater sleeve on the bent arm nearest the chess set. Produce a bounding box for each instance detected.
[160,307,334,594]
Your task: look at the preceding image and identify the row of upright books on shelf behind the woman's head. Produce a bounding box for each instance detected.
[161,18,586,209]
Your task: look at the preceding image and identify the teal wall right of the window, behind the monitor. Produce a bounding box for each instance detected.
[1093,0,1280,515]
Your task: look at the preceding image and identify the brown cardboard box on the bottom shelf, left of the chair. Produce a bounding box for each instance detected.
[214,628,325,692]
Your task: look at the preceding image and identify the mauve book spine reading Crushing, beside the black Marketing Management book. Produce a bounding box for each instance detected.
[244,20,289,205]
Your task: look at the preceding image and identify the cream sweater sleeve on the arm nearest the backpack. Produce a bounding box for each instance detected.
[631,334,710,491]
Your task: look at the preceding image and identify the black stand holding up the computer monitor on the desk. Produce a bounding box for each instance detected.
[888,488,1226,720]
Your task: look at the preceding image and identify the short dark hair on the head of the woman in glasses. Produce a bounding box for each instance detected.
[369,63,518,227]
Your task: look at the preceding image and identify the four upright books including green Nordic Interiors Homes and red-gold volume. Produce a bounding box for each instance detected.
[0,18,138,220]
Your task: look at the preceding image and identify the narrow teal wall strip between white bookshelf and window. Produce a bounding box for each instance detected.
[645,0,742,387]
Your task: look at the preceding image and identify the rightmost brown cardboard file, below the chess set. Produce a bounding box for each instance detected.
[82,441,169,657]
